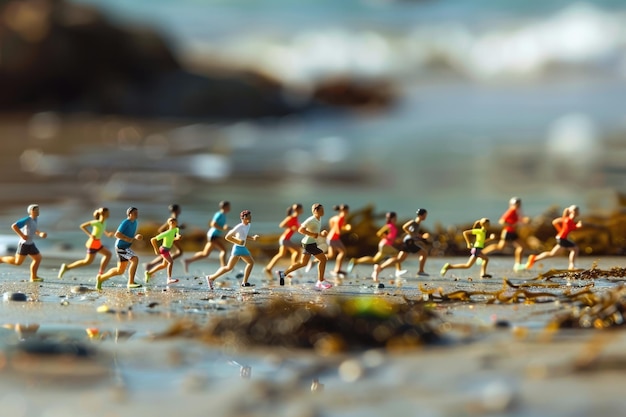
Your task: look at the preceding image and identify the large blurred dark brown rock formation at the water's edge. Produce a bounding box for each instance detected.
[0,0,390,120]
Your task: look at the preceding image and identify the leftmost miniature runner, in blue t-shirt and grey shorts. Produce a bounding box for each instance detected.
[0,204,48,282]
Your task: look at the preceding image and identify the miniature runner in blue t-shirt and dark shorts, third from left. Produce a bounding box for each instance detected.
[96,207,143,290]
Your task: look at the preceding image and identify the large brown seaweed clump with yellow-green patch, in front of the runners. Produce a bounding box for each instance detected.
[157,296,443,354]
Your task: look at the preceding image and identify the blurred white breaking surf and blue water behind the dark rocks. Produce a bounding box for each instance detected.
[73,0,626,87]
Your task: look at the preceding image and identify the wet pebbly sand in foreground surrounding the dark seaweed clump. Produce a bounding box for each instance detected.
[0,254,626,417]
